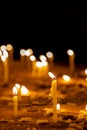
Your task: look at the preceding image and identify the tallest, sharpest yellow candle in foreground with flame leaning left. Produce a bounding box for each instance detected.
[48,72,57,123]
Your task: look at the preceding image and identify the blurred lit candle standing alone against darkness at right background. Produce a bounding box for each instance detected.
[67,49,75,75]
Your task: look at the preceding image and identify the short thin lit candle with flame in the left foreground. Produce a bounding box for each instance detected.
[13,86,18,117]
